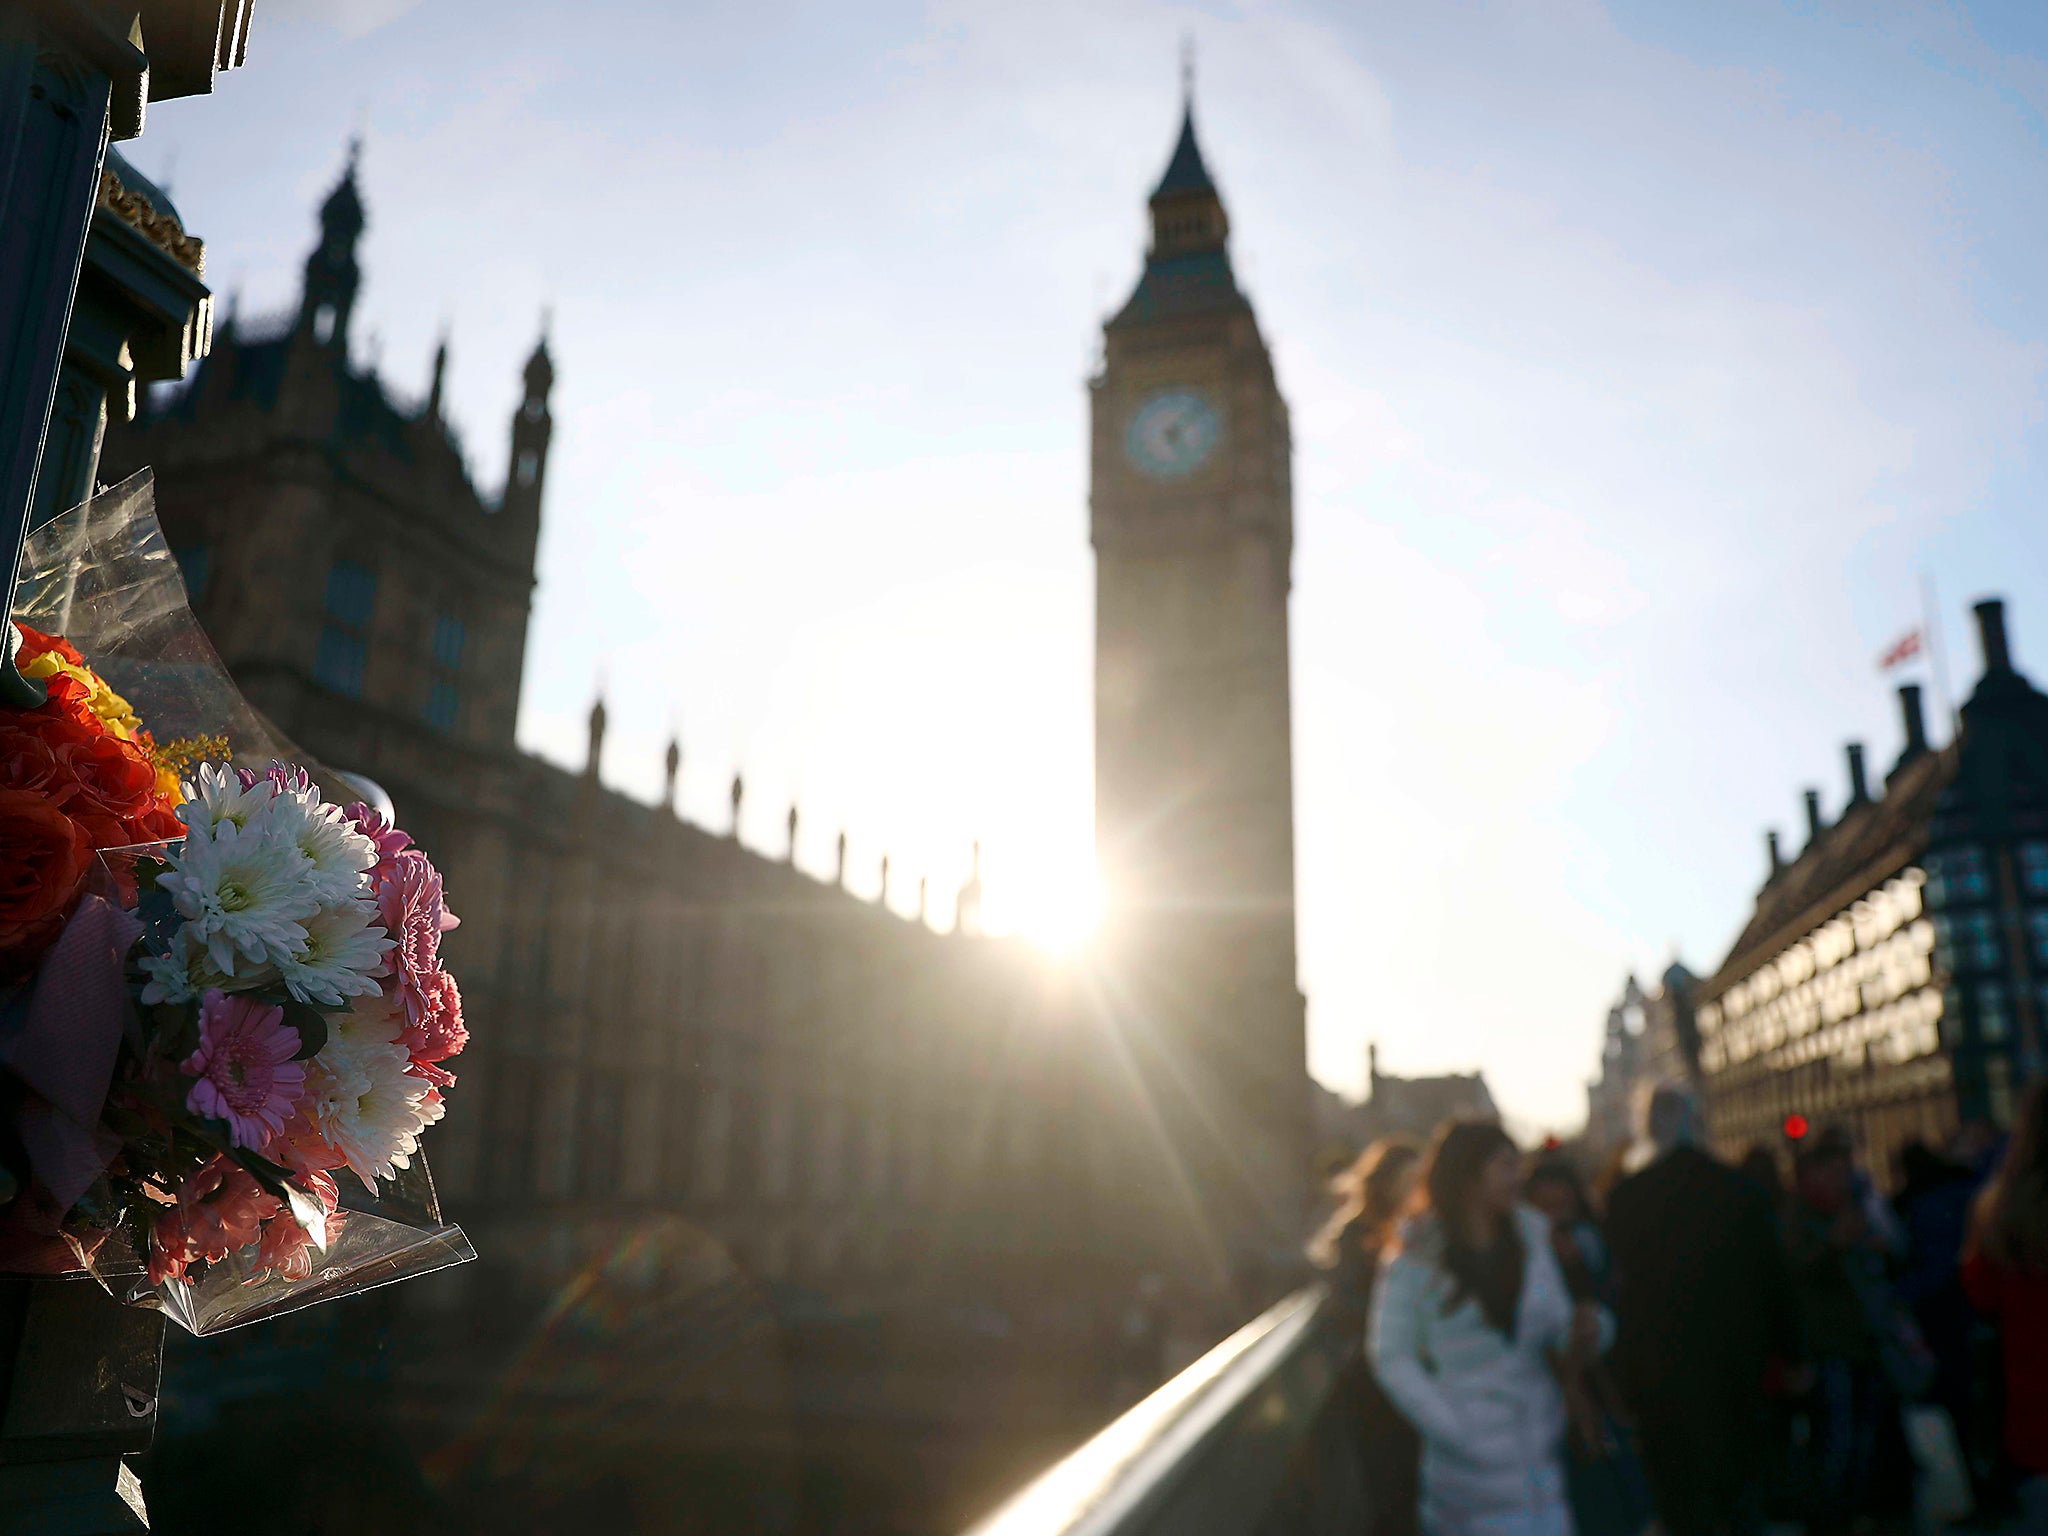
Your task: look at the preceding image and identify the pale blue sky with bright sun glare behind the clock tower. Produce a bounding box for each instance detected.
[133,0,2048,1126]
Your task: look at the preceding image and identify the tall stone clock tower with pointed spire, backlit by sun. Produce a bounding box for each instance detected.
[1090,93,1311,1294]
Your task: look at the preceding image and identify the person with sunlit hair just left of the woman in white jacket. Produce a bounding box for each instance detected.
[1309,1137,1421,1536]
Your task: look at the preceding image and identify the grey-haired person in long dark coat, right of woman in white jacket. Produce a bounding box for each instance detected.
[1608,1087,1796,1536]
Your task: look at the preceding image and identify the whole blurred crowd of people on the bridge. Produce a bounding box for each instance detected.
[1315,1083,2048,1536]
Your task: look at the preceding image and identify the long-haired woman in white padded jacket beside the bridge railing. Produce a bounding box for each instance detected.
[1368,1120,1612,1536]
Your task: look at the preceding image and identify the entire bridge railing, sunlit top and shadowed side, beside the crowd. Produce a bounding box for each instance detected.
[969,1286,1366,1536]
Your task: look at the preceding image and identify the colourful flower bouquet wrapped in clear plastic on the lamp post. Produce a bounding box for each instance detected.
[0,473,473,1333]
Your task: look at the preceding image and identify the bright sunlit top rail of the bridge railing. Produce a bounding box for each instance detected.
[969,1286,1333,1536]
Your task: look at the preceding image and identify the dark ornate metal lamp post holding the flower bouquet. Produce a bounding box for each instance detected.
[0,0,252,1536]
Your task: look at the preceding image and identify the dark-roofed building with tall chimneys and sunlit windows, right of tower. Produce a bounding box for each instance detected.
[1698,600,2048,1180]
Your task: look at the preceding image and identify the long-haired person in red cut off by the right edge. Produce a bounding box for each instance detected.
[1962,1079,2048,1532]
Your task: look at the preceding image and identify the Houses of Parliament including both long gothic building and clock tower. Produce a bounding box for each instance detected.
[100,96,1313,1532]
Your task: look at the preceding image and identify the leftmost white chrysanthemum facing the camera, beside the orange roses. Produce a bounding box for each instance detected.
[158,817,319,977]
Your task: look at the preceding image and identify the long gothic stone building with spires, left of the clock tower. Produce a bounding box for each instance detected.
[102,168,1128,1530]
